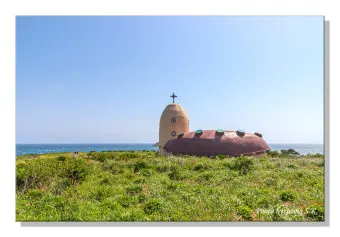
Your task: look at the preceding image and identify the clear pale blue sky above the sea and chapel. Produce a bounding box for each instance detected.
[16,16,323,143]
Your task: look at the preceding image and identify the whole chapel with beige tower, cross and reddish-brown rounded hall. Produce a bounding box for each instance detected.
[153,93,270,157]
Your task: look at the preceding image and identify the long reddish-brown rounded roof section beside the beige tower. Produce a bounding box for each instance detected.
[164,130,270,156]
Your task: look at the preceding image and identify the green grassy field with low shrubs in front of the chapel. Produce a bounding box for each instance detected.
[16,151,324,221]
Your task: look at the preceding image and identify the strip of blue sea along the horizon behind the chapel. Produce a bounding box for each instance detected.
[16,143,323,156]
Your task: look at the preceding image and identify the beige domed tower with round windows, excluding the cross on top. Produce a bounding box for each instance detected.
[154,103,189,155]
